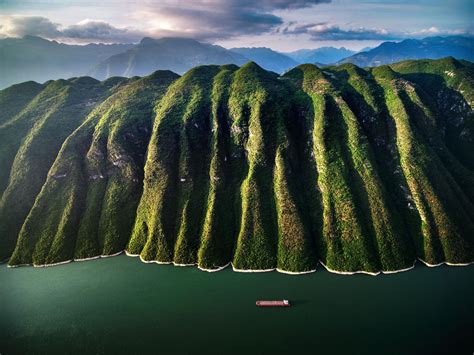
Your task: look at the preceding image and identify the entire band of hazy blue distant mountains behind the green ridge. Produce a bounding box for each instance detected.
[0,36,474,89]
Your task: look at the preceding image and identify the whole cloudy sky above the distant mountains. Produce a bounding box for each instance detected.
[0,0,474,51]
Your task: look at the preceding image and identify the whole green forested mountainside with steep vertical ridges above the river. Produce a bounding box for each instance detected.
[0,58,474,272]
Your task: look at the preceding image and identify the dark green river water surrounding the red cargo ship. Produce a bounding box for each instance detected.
[0,255,474,355]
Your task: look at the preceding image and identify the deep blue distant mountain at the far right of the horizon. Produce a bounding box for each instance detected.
[339,36,474,67]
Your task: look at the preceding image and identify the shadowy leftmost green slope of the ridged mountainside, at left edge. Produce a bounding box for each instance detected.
[0,77,130,259]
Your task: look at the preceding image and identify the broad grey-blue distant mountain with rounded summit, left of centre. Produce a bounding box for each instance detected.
[89,37,248,79]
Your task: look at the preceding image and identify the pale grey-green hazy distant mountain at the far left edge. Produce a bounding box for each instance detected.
[0,36,133,88]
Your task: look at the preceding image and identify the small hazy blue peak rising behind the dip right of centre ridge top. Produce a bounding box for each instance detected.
[231,47,299,73]
